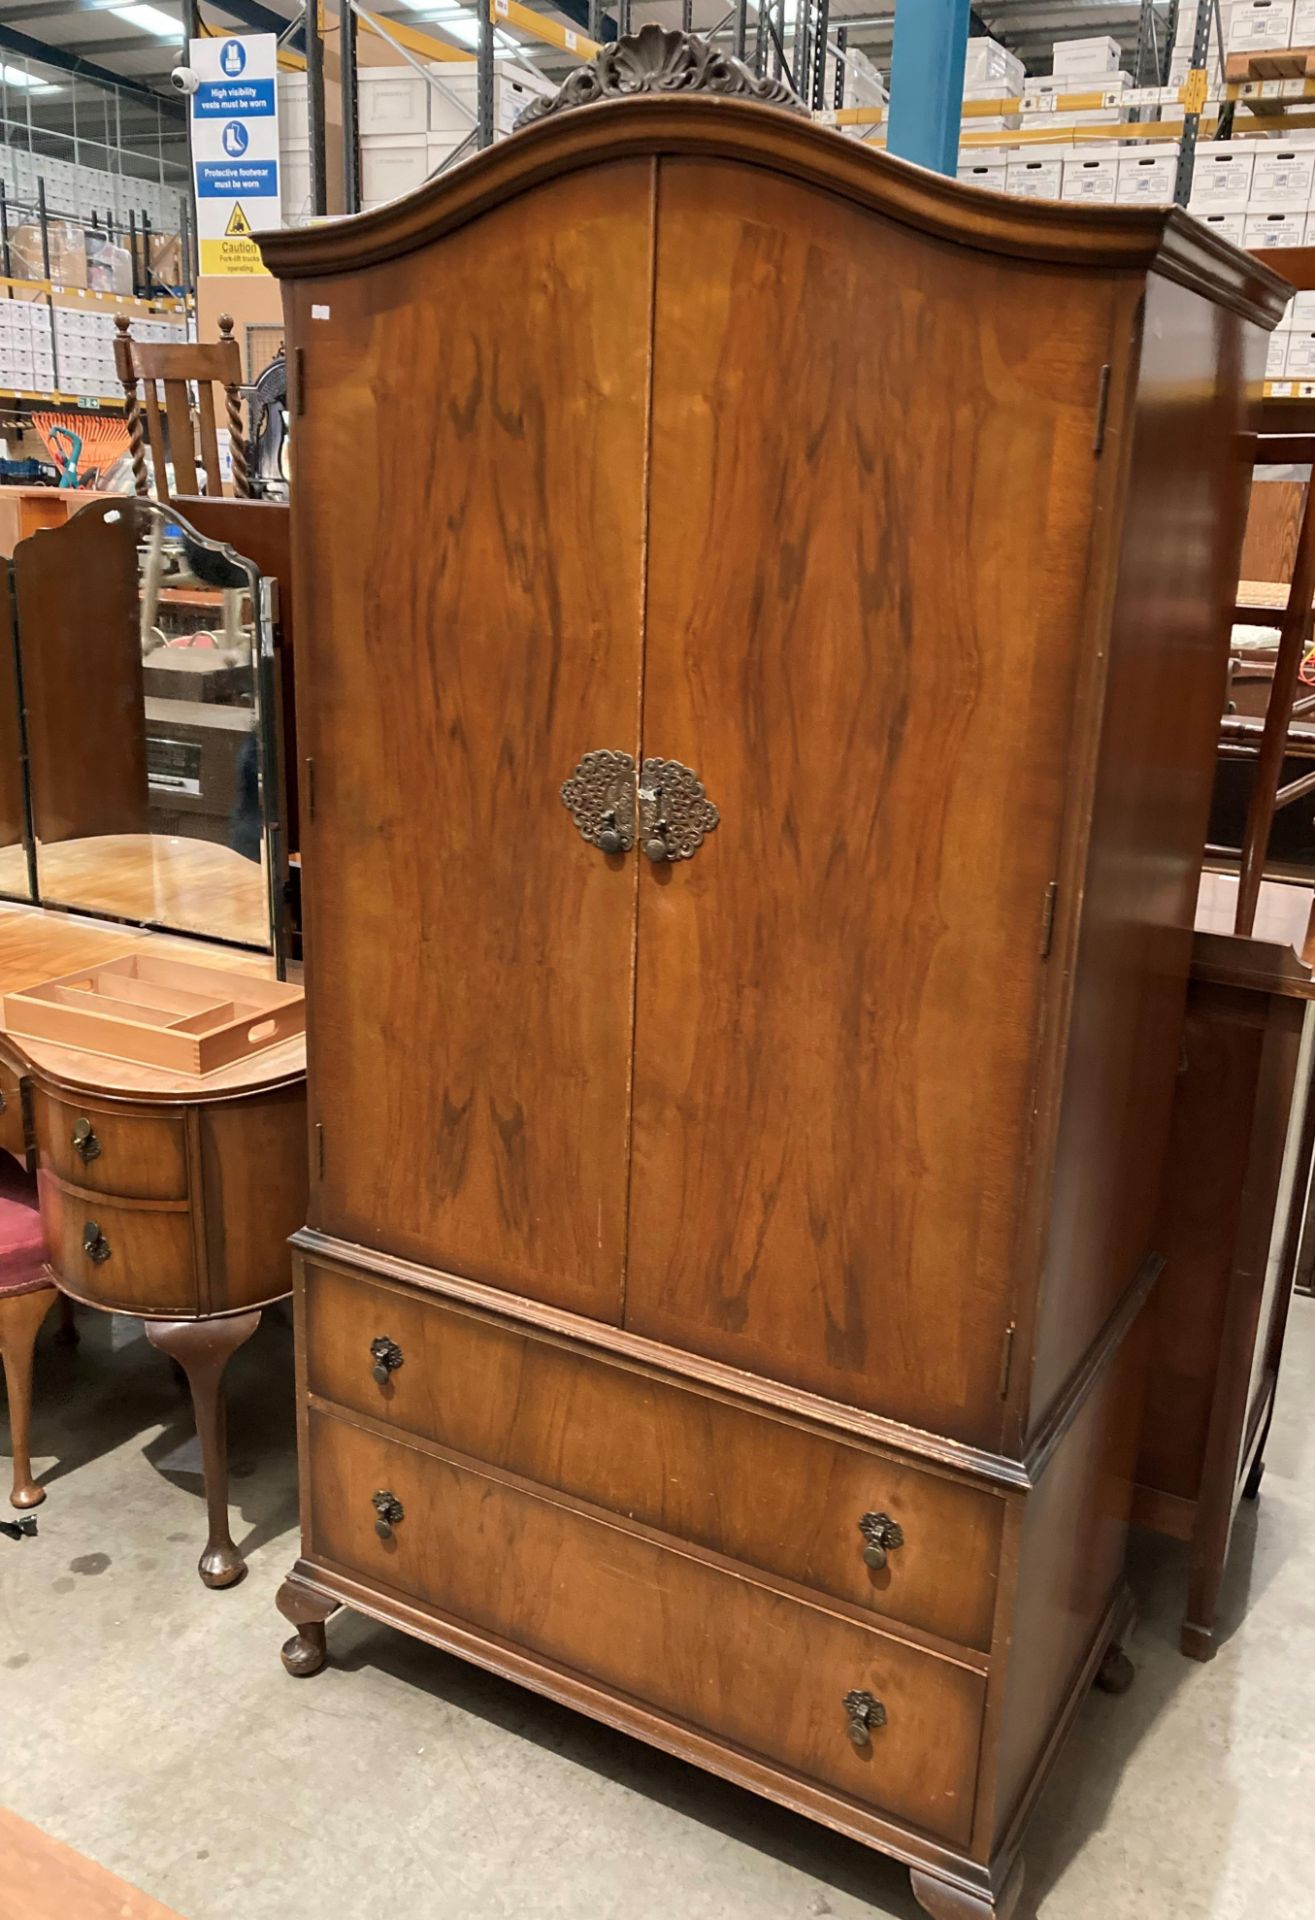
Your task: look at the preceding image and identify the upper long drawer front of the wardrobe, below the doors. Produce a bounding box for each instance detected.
[305,1261,1004,1649]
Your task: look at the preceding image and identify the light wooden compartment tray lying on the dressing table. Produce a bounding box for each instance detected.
[4,954,305,1075]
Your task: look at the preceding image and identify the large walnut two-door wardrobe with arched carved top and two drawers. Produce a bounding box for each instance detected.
[263,29,1282,1920]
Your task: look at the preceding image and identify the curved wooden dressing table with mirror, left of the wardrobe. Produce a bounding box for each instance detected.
[0,501,307,1588]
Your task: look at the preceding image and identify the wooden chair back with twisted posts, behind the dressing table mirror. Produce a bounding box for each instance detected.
[113,313,250,499]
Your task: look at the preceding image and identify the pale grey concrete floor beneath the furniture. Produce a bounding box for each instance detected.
[0,1300,1315,1920]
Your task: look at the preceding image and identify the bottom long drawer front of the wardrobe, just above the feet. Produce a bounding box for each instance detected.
[309,1413,985,1845]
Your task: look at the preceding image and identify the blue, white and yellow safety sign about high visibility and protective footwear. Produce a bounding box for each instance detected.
[188,33,280,275]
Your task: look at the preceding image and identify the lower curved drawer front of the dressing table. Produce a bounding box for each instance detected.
[36,1173,200,1315]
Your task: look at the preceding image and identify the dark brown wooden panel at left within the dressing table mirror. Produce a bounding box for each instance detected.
[13,501,148,847]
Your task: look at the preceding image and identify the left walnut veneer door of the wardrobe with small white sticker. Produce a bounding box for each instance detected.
[294,161,653,1319]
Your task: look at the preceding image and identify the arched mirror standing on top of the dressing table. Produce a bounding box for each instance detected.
[0,497,286,972]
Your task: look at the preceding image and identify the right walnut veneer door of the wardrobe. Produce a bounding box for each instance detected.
[626,159,1113,1444]
